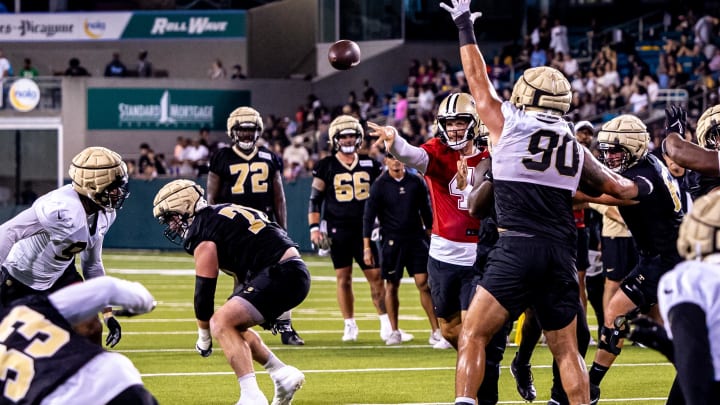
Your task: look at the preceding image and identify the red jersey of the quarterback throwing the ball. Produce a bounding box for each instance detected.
[421,138,490,243]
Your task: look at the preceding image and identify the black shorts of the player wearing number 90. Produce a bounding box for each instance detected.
[480,236,580,330]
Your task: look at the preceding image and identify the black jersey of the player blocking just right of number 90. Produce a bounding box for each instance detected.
[619,154,684,266]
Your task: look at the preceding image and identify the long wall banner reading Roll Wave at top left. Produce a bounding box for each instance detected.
[0,10,247,42]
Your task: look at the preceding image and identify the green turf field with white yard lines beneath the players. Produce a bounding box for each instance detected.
[104,251,674,405]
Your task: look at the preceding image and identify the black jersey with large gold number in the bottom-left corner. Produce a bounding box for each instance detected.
[0,295,103,404]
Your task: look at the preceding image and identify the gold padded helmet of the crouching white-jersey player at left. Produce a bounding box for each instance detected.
[68,146,130,209]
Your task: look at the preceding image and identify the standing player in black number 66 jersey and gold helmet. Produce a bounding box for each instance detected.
[308,115,392,342]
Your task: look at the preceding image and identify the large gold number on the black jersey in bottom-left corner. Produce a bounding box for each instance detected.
[0,306,70,402]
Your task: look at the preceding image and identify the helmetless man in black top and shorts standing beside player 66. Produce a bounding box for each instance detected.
[363,153,440,345]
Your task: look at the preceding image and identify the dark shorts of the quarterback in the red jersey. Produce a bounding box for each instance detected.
[428,257,475,319]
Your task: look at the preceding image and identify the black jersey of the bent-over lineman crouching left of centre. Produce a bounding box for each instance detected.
[184,204,297,282]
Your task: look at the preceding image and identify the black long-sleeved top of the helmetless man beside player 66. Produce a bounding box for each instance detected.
[363,172,432,240]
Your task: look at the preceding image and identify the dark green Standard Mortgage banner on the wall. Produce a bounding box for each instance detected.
[87,88,251,131]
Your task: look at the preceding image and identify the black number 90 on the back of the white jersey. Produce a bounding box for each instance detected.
[522,131,580,177]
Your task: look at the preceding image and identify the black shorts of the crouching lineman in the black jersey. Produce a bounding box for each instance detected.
[230,258,310,326]
